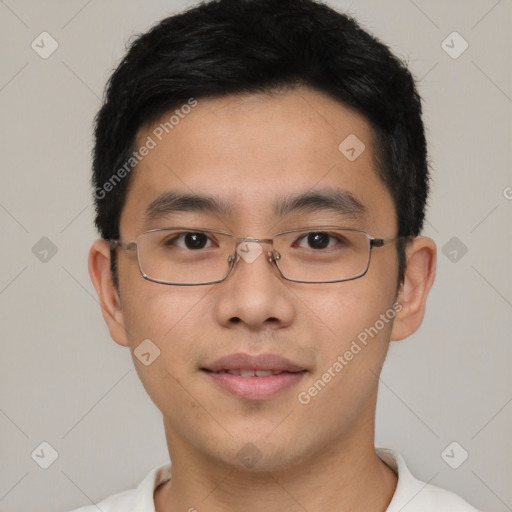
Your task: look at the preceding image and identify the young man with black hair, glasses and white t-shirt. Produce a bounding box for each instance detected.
[77,0,475,512]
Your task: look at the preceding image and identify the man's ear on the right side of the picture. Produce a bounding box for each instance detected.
[391,236,437,341]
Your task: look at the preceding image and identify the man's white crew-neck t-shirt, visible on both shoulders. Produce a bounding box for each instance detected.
[68,448,478,512]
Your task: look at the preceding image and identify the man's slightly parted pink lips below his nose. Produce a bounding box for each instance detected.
[202,353,307,400]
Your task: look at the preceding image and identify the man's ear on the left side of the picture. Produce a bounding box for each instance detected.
[89,239,128,346]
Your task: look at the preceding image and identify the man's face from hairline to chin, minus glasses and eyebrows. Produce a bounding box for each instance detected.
[96,88,408,470]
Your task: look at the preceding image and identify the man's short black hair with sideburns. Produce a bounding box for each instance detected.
[92,0,429,286]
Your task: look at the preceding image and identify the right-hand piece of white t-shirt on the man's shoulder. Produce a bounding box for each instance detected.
[377,448,478,512]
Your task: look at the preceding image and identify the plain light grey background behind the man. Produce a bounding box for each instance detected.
[0,0,512,512]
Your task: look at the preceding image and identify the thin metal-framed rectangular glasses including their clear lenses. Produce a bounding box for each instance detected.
[109,226,408,286]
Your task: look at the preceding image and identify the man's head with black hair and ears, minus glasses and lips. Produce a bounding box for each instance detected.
[90,0,435,469]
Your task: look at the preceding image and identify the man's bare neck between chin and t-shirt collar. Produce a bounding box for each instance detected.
[155,414,397,512]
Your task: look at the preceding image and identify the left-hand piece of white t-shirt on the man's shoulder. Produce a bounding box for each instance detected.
[70,464,171,512]
